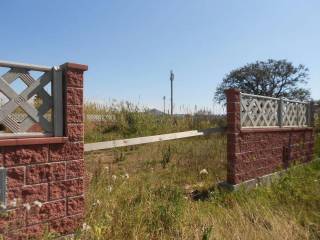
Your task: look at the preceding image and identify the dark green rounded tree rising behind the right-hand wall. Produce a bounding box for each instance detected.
[215,59,310,103]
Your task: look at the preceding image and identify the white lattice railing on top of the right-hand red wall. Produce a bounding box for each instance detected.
[240,93,312,128]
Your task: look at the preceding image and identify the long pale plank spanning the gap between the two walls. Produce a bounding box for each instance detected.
[84,128,226,152]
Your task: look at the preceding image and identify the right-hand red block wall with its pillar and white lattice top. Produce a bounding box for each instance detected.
[226,89,314,187]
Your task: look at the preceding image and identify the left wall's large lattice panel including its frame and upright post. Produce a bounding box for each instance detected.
[0,61,63,136]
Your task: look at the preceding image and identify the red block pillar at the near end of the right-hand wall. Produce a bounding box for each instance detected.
[225,89,241,184]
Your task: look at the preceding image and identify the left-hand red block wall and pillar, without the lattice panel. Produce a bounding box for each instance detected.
[0,63,87,239]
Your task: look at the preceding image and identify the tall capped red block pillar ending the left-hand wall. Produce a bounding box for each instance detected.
[49,63,88,235]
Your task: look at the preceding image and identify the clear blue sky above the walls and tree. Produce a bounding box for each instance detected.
[0,0,320,113]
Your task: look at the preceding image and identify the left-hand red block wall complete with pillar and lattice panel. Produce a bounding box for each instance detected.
[0,62,87,239]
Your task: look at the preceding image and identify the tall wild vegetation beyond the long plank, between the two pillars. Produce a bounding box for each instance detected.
[85,102,225,142]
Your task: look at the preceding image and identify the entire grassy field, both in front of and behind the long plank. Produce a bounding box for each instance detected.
[68,103,320,240]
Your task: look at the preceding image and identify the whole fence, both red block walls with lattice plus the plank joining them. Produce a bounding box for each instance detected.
[0,61,314,239]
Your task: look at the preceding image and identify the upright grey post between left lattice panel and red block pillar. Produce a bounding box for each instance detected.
[52,69,63,137]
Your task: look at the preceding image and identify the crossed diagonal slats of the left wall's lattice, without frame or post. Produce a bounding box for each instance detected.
[0,68,52,133]
